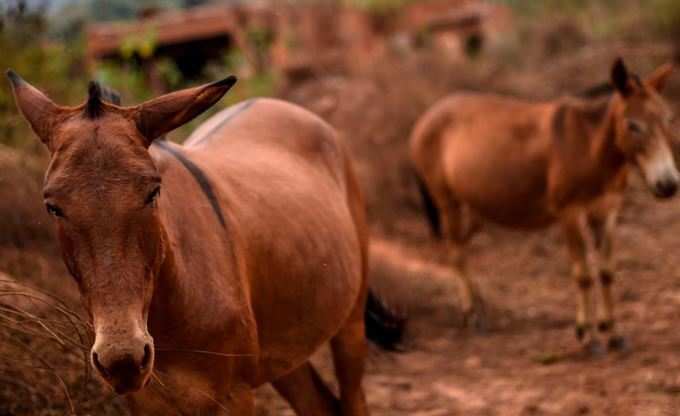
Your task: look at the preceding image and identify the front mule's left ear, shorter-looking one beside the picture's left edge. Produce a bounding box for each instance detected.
[6,69,60,148]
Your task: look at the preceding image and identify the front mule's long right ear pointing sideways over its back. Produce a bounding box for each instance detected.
[134,75,236,144]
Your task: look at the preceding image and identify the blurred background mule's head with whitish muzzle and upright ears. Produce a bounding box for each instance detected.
[611,59,680,198]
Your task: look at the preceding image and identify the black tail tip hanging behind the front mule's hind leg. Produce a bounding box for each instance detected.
[364,289,406,351]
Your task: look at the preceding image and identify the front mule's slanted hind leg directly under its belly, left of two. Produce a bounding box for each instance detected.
[272,362,340,416]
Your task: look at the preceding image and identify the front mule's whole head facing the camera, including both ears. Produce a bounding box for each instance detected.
[7,71,236,393]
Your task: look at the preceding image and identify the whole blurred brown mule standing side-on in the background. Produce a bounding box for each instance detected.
[410,60,679,348]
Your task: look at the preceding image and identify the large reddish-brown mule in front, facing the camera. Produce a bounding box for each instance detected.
[8,71,402,415]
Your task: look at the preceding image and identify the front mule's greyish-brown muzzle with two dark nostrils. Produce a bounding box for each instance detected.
[92,343,154,394]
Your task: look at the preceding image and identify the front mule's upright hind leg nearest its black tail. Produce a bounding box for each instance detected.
[331,296,369,416]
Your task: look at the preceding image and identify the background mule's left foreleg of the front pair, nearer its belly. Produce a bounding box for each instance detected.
[563,215,601,353]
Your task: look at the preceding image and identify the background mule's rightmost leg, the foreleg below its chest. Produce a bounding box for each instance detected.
[589,210,626,350]
